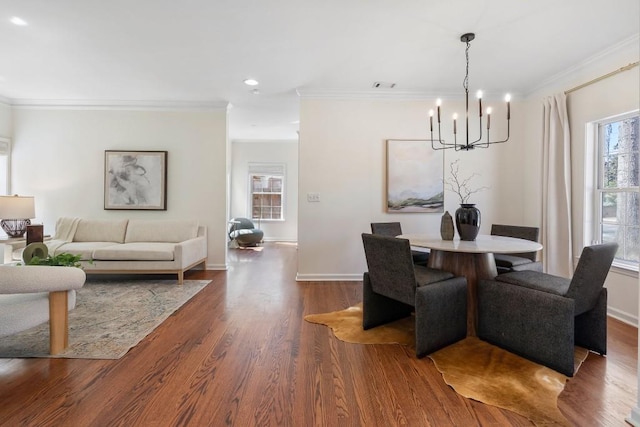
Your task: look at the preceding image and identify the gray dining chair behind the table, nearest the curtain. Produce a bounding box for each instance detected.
[491,224,542,274]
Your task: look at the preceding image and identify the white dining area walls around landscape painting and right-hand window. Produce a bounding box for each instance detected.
[297,38,640,324]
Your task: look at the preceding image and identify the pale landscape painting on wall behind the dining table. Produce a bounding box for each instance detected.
[387,139,444,213]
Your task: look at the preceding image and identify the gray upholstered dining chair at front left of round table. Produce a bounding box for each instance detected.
[362,233,467,357]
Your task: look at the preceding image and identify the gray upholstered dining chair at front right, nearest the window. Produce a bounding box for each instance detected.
[478,243,618,377]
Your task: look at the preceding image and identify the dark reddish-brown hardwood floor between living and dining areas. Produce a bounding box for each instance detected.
[0,243,637,427]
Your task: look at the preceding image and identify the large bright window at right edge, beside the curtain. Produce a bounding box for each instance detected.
[594,112,640,271]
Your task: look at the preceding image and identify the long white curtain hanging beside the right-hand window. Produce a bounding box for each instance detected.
[541,93,573,278]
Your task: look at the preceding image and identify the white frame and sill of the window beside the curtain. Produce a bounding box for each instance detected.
[585,110,640,273]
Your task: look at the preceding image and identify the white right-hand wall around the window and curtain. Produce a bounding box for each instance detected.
[526,37,640,326]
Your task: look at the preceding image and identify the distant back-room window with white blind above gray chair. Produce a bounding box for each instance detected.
[249,164,284,221]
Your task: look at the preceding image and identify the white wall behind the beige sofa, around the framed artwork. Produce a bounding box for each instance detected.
[11,107,227,269]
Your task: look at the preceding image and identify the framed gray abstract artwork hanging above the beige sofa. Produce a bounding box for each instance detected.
[104,150,167,210]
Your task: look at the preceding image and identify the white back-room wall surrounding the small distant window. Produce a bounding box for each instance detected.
[229,141,298,241]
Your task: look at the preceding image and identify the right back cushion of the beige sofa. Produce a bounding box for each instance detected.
[124,219,198,243]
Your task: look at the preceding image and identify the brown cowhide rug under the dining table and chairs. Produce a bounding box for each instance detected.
[304,304,588,426]
